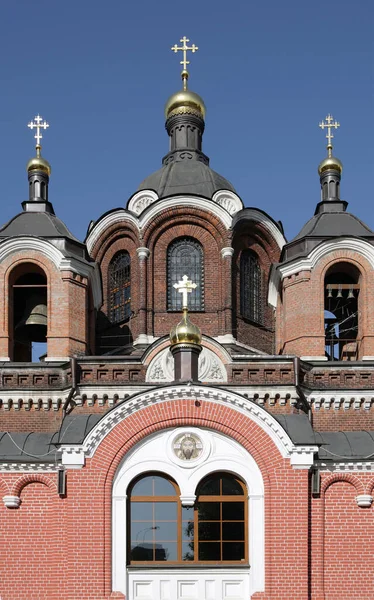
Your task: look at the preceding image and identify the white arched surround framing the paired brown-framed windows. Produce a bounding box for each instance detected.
[112,428,265,598]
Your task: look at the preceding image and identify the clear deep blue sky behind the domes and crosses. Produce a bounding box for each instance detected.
[0,0,374,239]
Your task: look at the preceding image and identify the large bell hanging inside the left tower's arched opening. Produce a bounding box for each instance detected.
[15,294,48,342]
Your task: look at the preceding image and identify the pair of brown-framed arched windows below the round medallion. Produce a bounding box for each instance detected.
[129,473,248,565]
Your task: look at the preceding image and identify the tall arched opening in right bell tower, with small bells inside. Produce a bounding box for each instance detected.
[324,262,361,360]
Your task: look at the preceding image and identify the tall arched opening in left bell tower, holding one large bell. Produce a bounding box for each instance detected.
[9,263,48,362]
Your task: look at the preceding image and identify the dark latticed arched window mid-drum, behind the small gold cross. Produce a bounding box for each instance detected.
[167,238,204,311]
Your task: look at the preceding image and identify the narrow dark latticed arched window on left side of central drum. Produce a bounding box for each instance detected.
[108,252,131,323]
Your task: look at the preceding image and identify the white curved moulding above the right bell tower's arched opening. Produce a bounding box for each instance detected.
[278,237,374,279]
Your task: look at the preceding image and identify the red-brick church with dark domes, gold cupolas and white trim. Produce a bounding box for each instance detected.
[0,37,374,600]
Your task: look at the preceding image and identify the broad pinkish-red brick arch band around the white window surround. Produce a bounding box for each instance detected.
[86,399,298,594]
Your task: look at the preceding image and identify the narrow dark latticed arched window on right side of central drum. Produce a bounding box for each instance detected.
[240,250,263,324]
